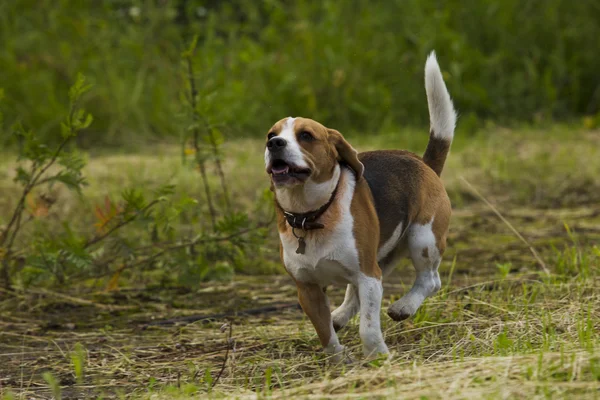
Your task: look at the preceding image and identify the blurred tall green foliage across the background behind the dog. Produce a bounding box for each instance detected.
[0,0,600,146]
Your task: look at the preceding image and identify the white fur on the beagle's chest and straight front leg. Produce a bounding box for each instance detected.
[280,169,388,356]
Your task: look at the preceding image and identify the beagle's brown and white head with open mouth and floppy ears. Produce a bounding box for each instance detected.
[265,117,364,188]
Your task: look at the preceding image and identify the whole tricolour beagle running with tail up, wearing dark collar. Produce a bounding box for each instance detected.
[265,52,456,361]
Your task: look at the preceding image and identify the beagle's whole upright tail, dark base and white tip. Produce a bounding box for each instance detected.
[423,51,456,176]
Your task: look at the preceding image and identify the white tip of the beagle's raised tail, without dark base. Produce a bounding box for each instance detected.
[425,51,456,140]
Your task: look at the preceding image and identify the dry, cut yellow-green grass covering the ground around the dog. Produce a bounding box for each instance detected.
[0,127,600,399]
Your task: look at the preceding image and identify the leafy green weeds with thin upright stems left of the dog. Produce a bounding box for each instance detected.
[0,54,265,290]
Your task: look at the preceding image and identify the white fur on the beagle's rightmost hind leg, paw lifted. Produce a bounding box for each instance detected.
[388,219,442,317]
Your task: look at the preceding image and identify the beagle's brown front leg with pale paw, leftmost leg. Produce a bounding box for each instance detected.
[296,282,344,362]
